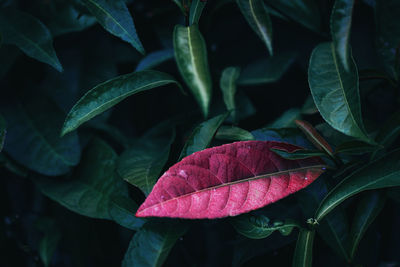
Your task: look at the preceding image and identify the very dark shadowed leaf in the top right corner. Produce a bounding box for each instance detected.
[375,0,400,80]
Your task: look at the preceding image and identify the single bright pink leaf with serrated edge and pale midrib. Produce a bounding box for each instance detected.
[136,141,325,219]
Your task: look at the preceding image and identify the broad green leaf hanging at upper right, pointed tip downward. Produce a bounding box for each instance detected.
[308,43,371,142]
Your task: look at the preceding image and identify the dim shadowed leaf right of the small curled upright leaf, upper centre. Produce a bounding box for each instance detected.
[238,53,295,85]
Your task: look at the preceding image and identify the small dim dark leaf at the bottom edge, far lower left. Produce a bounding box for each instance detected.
[35,217,61,267]
